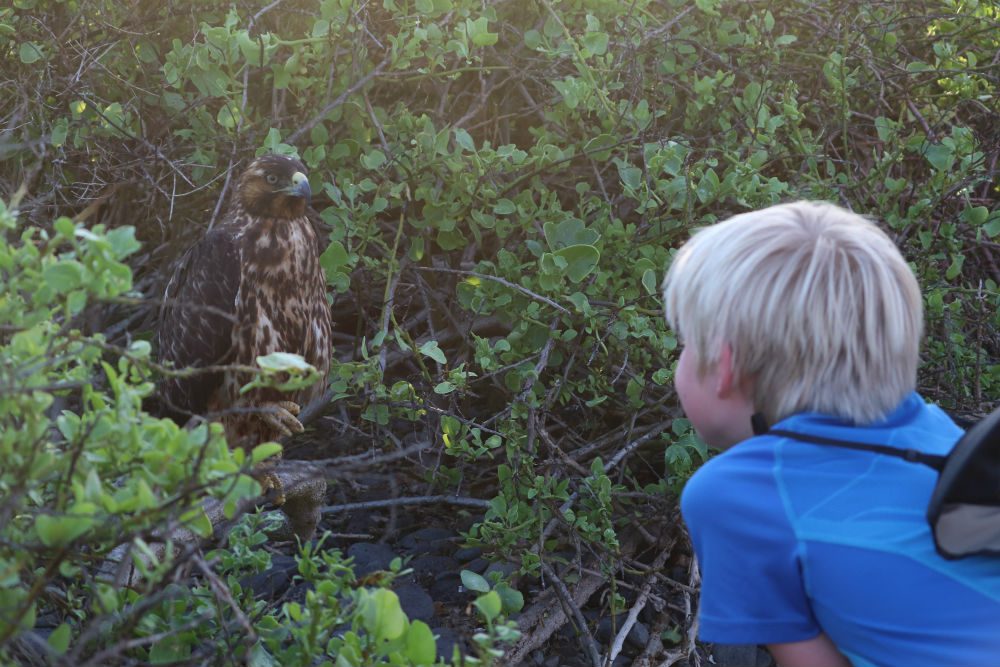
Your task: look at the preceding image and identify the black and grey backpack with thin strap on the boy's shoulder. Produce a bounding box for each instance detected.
[751,408,1000,559]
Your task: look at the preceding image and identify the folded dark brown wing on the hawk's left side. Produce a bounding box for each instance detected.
[157,228,241,420]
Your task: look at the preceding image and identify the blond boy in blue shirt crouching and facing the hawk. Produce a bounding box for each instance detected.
[664,202,1000,667]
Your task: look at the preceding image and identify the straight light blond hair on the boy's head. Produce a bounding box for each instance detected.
[663,201,923,424]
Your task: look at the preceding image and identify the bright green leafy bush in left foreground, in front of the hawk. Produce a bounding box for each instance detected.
[0,198,259,655]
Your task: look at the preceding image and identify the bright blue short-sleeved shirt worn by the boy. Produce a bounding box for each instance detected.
[681,393,1000,667]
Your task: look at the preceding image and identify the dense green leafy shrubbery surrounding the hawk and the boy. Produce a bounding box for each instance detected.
[0,0,1000,664]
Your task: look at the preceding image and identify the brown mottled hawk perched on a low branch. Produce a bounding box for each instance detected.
[157,155,332,492]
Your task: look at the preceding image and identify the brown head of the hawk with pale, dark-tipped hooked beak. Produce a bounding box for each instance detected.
[236,155,312,218]
